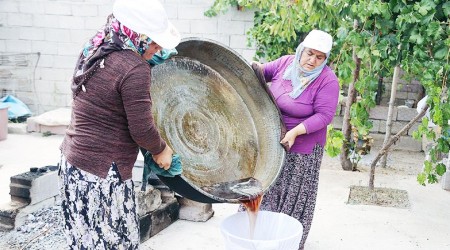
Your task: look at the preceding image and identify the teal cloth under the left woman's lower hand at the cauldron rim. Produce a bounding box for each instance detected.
[141,148,183,190]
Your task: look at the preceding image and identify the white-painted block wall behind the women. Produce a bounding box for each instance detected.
[0,0,255,115]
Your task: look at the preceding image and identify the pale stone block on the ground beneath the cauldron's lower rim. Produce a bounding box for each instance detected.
[177,197,214,222]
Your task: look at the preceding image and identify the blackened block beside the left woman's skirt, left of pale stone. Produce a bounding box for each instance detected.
[139,198,180,242]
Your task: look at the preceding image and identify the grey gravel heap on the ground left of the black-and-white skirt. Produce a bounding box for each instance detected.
[0,206,67,250]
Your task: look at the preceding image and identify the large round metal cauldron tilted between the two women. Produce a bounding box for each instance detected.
[151,38,285,203]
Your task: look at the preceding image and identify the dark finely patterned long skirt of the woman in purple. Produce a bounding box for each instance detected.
[239,145,323,249]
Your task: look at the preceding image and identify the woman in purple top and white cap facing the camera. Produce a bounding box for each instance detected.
[246,30,339,249]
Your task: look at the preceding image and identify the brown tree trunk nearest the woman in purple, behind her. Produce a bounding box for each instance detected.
[339,20,361,171]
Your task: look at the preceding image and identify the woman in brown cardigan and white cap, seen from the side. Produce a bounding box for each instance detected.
[59,0,180,249]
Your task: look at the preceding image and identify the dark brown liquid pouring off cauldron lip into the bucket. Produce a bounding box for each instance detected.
[202,177,263,239]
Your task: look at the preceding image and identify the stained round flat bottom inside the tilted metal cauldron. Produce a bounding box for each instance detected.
[152,59,258,185]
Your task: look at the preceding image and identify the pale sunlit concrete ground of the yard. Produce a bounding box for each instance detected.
[0,133,450,250]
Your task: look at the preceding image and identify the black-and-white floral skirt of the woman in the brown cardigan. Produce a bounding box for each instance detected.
[59,155,140,249]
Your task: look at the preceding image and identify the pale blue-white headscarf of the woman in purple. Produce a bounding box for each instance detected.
[283,43,330,99]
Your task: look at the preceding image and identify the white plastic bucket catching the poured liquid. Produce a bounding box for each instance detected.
[220,211,303,250]
